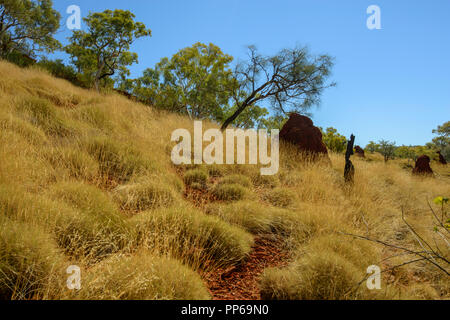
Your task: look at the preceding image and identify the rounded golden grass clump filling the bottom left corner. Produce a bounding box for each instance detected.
[0,217,65,300]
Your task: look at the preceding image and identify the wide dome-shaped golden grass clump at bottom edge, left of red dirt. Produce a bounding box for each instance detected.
[73,252,210,300]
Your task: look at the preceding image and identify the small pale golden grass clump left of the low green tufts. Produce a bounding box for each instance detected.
[114,178,176,212]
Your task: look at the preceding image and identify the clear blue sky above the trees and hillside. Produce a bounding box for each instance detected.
[47,0,450,146]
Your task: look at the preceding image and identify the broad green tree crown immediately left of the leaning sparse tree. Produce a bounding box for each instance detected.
[134,43,235,120]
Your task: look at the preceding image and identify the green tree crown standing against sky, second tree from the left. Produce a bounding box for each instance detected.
[66,10,151,89]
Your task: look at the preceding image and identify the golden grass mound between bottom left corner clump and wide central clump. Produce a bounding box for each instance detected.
[50,182,134,262]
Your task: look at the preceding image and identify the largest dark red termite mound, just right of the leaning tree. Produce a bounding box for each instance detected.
[280,113,328,159]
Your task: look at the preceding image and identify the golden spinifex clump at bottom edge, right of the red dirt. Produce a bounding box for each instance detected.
[261,235,379,300]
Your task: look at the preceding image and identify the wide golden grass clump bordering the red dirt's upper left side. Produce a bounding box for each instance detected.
[130,207,253,268]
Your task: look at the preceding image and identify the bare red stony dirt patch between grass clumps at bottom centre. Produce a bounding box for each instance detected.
[203,235,289,300]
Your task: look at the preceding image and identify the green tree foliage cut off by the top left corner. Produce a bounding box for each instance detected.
[0,0,61,58]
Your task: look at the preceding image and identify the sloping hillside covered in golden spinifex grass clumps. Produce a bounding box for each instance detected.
[0,62,450,299]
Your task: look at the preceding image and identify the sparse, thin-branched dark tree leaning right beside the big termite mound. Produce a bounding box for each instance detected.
[222,46,335,130]
